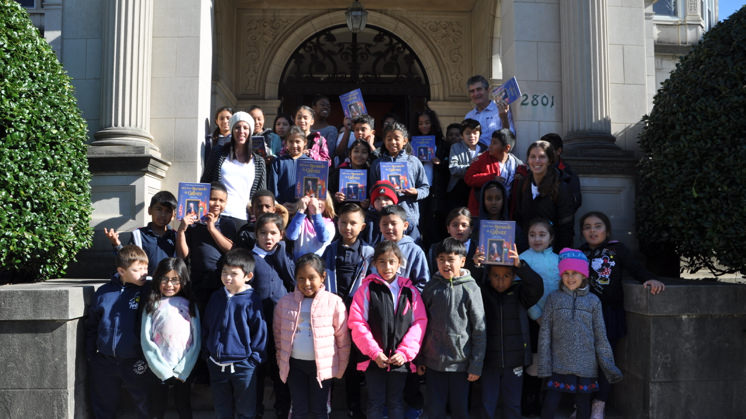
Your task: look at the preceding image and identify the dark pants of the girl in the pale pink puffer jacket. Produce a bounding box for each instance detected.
[288,358,332,419]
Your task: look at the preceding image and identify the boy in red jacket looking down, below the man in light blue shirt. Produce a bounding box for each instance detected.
[464,128,522,215]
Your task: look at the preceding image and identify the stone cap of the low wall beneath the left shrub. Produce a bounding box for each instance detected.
[0,279,106,321]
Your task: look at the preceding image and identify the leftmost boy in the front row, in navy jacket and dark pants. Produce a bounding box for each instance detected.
[85,245,151,418]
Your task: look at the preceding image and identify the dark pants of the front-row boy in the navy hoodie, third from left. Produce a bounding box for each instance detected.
[207,359,256,419]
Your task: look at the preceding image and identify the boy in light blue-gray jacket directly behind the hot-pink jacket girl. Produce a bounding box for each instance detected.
[378,205,430,290]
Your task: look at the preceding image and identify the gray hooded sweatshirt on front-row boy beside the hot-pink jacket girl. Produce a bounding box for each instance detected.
[421,269,487,375]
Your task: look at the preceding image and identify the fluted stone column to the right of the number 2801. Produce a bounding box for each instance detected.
[560,0,614,152]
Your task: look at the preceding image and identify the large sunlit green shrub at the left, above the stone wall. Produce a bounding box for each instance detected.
[0,0,92,282]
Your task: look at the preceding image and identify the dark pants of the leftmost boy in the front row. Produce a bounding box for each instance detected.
[88,353,152,418]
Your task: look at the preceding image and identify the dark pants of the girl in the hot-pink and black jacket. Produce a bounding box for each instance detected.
[365,361,407,419]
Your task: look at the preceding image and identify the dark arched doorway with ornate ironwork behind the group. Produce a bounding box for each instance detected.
[278,25,430,128]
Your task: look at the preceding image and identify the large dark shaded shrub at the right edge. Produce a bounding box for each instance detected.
[637,7,746,275]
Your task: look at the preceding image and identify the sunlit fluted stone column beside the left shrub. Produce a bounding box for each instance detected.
[93,0,160,156]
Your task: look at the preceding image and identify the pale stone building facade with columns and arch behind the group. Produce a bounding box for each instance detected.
[21,0,717,275]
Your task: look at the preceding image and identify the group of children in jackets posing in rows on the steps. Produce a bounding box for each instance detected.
[86,108,663,419]
